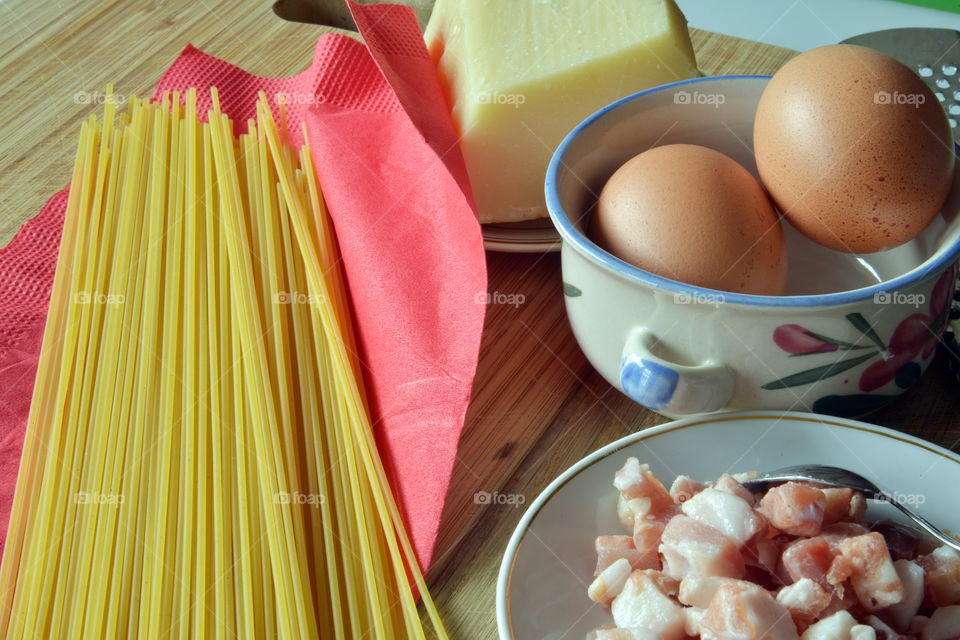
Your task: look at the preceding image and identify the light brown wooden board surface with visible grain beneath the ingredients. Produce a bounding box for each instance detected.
[0,0,960,640]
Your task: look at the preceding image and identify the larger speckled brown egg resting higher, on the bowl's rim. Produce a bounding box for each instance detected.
[753,45,953,253]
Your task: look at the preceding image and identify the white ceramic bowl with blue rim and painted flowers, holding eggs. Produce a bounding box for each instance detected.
[546,76,960,417]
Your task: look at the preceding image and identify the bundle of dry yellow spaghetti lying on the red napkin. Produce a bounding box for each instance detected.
[0,90,446,639]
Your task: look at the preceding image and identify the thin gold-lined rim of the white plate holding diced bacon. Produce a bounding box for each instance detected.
[496,411,960,640]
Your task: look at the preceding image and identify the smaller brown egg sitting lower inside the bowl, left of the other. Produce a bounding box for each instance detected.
[590,144,787,295]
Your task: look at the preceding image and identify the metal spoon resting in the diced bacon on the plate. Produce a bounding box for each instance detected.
[743,464,960,551]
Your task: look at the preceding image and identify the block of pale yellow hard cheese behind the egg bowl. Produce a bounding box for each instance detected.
[425,0,698,222]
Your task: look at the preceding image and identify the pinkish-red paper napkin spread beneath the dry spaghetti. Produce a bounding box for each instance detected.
[0,3,486,568]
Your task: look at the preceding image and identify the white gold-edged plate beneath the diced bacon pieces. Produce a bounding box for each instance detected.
[497,412,960,640]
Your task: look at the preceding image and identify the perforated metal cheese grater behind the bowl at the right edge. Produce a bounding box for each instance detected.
[841,29,960,380]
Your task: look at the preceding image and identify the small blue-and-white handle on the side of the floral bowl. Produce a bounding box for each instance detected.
[620,328,735,416]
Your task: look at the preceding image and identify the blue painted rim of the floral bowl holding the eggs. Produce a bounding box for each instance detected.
[544,75,960,307]
